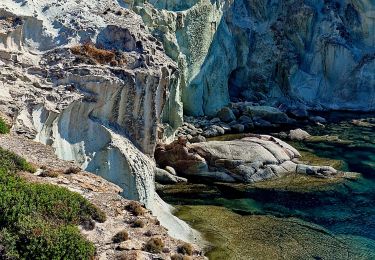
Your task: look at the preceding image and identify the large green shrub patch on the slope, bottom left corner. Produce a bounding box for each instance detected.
[0,148,105,259]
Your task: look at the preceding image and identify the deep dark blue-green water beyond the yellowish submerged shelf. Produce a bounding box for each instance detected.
[162,114,375,250]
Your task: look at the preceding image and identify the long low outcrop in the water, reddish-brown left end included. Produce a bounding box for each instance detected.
[155,135,344,183]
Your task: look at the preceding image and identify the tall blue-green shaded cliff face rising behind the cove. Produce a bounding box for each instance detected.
[133,0,375,116]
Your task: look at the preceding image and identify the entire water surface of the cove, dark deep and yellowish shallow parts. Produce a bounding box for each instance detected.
[161,113,375,259]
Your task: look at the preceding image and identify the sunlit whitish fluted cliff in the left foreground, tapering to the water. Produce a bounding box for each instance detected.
[0,0,200,243]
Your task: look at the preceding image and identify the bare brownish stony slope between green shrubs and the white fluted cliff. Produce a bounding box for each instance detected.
[0,135,205,260]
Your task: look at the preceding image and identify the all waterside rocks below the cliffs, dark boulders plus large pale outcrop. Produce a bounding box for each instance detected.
[155,102,363,184]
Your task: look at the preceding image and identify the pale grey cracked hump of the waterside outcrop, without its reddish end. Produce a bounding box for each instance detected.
[189,135,300,183]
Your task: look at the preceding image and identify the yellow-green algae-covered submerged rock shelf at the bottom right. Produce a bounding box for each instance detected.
[176,206,375,260]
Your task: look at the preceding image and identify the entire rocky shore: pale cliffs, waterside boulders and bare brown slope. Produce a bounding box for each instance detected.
[0,0,375,260]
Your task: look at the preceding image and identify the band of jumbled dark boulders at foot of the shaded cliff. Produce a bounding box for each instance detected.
[175,102,326,143]
